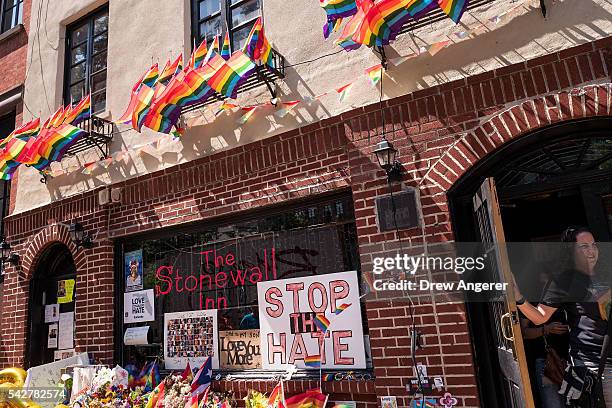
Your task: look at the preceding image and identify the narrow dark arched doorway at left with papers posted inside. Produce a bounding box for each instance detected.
[25,242,76,367]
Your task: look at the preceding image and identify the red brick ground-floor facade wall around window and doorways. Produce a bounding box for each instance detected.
[0,39,612,407]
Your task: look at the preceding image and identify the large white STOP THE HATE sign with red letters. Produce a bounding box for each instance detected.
[257,271,366,369]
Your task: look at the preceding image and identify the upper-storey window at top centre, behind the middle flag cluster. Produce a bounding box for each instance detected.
[192,0,262,50]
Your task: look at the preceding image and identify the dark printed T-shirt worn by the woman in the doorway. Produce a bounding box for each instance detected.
[542,270,612,367]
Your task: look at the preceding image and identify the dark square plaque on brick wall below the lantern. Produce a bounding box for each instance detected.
[376,189,419,232]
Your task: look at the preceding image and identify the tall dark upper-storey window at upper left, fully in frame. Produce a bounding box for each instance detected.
[64,9,108,113]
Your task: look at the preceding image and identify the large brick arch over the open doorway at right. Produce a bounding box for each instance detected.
[422,83,612,193]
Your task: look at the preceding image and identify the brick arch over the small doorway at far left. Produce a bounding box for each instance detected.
[21,224,86,282]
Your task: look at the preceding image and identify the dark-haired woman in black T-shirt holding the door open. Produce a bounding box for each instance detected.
[514,227,612,407]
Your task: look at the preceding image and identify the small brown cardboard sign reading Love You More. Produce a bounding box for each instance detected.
[219,329,261,370]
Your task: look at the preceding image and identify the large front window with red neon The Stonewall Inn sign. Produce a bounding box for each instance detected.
[116,195,366,376]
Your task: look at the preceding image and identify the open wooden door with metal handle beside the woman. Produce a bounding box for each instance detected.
[473,178,534,408]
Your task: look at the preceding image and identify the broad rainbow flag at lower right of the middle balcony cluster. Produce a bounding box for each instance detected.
[206,50,255,99]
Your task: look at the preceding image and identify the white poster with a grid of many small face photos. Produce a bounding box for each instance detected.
[164,309,219,370]
